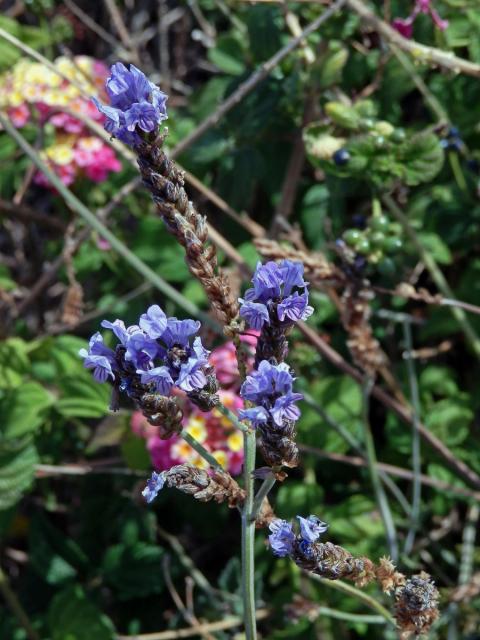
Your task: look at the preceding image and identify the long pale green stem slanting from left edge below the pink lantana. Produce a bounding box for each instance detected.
[0,112,213,325]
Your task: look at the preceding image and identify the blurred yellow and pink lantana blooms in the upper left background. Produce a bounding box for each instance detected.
[0,56,121,187]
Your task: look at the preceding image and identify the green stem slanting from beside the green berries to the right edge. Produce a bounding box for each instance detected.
[383,190,480,357]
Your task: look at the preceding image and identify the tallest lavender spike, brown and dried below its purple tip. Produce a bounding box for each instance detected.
[95,63,238,325]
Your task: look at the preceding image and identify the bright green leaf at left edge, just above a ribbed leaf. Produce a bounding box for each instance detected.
[0,382,54,438]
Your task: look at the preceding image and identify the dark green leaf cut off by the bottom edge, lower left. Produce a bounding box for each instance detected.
[48,585,116,640]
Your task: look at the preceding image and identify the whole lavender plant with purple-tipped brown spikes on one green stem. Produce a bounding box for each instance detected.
[80,63,438,640]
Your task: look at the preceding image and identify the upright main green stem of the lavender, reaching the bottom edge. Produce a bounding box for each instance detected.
[242,431,257,640]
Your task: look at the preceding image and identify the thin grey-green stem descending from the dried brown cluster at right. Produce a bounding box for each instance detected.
[363,380,398,562]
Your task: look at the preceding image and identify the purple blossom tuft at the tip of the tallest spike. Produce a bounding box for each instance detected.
[93,62,167,145]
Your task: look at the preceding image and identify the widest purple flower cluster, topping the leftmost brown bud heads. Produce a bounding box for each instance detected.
[80,305,215,396]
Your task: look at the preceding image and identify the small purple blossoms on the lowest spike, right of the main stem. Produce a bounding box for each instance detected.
[268,516,328,558]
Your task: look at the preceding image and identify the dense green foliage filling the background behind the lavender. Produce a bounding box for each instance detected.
[0,0,480,640]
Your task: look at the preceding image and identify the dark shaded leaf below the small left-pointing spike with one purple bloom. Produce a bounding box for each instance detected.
[102,542,164,600]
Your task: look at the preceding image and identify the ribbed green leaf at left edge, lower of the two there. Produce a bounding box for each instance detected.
[0,442,38,511]
